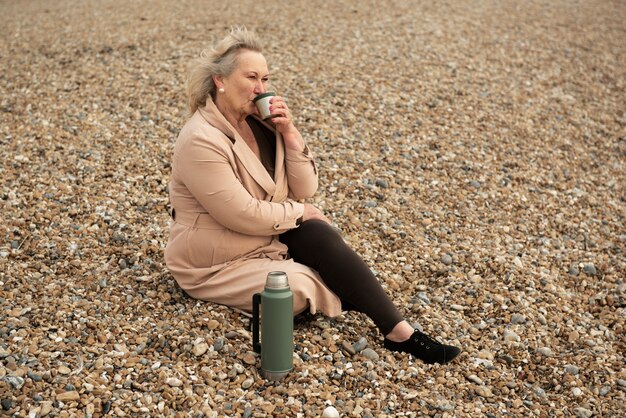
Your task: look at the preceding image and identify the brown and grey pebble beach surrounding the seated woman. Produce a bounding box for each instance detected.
[0,0,626,418]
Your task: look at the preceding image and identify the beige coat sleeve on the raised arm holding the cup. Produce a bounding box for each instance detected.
[285,146,318,200]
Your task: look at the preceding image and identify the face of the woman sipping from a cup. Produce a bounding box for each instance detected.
[218,50,269,116]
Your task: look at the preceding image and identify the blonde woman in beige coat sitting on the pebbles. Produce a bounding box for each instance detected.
[165,29,460,364]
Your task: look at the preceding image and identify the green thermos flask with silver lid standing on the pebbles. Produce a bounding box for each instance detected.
[252,271,293,380]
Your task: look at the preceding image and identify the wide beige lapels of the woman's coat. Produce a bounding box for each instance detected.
[198,96,284,196]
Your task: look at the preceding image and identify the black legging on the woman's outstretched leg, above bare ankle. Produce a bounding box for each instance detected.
[280,220,403,335]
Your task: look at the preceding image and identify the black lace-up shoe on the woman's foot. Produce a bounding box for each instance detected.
[383,330,461,364]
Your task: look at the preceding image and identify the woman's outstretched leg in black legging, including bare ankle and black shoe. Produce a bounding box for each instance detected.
[280,220,461,364]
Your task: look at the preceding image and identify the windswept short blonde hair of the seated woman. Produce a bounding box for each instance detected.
[187,27,261,115]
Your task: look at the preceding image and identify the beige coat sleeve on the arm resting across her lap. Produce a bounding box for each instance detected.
[176,135,304,236]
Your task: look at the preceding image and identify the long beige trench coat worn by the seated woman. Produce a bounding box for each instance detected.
[165,98,341,316]
